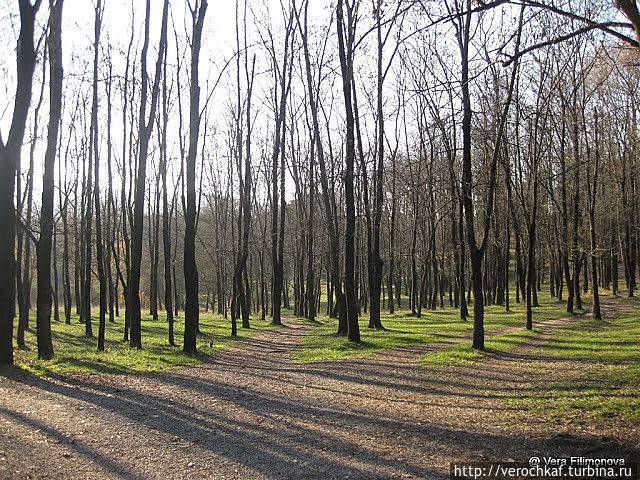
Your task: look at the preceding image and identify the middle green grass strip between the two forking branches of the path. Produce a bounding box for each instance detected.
[294,286,566,363]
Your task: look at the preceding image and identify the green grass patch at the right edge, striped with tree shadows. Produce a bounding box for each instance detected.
[508,306,640,422]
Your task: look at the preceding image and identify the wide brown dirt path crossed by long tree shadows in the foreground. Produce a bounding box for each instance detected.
[0,302,638,480]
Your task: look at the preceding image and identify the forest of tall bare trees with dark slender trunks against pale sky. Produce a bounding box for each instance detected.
[0,0,640,364]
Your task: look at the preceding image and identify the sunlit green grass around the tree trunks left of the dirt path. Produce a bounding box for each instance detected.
[9,312,270,375]
